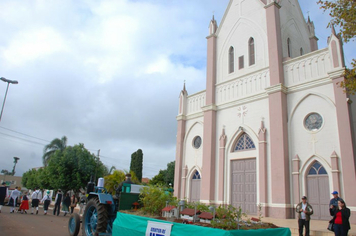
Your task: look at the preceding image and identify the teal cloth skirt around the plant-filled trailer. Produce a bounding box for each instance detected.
[112,212,291,236]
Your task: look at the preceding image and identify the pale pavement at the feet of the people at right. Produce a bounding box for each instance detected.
[262,217,356,236]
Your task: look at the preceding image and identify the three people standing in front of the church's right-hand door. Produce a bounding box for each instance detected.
[296,191,351,236]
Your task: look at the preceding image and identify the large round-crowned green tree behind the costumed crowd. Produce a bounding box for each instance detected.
[46,144,108,195]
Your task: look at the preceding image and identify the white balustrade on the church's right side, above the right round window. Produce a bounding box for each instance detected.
[283,48,332,87]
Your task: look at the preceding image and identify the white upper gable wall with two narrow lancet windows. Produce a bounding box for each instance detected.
[217,0,268,84]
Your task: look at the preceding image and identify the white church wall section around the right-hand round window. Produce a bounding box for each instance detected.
[288,83,340,202]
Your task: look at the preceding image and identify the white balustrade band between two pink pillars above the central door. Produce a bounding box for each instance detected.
[216,69,270,105]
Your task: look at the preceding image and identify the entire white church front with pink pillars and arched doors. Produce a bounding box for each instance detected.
[174,0,356,223]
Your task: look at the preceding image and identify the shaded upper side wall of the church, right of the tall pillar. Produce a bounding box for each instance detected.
[280,0,311,58]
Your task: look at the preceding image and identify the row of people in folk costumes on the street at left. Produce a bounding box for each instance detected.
[0,182,85,216]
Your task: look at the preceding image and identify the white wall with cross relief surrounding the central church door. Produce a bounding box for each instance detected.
[215,98,270,204]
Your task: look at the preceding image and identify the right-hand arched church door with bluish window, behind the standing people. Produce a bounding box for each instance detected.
[307,161,330,220]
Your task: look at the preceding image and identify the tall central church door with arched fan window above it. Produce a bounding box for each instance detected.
[231,133,257,214]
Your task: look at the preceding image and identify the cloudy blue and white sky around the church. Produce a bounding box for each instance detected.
[0,0,356,178]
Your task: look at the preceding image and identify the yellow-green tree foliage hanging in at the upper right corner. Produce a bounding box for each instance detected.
[318,0,356,94]
